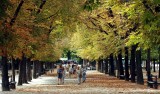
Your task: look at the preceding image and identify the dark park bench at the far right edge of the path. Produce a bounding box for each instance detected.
[147,74,160,89]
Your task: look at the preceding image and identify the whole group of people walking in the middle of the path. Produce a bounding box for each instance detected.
[57,64,86,85]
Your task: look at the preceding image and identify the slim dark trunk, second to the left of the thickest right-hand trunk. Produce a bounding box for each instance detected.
[125,47,129,81]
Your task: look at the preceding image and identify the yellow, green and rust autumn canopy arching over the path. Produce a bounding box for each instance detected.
[0,0,160,61]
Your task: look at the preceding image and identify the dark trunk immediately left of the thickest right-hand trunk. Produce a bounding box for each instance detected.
[130,45,136,83]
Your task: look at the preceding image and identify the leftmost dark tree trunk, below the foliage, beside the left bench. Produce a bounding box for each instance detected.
[2,56,10,91]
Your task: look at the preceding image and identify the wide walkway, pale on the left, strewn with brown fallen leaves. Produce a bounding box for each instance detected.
[0,71,160,94]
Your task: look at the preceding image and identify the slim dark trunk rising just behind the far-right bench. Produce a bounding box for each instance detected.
[147,49,152,81]
